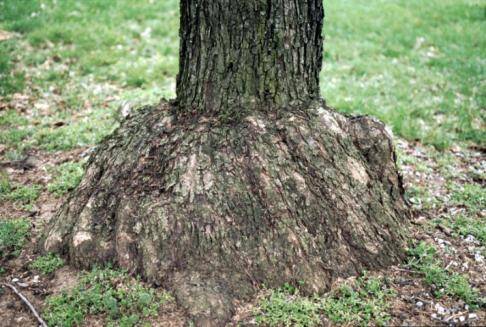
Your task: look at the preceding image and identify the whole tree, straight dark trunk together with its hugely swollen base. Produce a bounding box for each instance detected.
[40,0,407,326]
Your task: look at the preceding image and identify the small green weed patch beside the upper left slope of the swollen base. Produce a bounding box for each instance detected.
[47,162,84,197]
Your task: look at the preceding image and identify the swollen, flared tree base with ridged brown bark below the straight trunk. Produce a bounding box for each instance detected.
[41,103,408,326]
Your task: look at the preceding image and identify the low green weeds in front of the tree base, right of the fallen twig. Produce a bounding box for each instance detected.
[43,268,172,327]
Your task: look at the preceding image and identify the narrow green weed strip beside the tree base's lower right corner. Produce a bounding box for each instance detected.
[408,242,485,307]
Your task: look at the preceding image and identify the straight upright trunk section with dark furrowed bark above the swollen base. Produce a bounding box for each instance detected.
[177,0,324,120]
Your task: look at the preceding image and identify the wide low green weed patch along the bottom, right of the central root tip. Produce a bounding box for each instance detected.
[256,274,394,326]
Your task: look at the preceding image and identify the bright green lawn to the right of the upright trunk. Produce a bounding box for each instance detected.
[322,0,486,147]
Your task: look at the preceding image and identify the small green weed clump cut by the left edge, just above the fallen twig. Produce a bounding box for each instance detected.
[0,219,30,261]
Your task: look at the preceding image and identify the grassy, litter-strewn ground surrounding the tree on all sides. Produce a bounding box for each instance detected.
[0,0,486,326]
